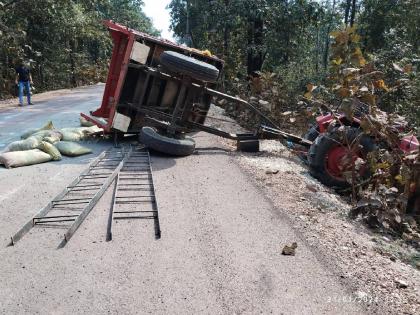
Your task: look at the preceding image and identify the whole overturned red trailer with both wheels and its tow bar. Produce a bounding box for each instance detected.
[82,21,310,155]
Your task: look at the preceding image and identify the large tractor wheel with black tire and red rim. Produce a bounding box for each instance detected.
[308,127,376,189]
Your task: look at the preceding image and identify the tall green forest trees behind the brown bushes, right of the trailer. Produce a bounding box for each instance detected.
[169,0,420,130]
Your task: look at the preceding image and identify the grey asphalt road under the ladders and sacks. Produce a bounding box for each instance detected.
[0,86,364,314]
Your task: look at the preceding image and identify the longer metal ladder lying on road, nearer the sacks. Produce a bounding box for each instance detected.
[9,147,132,248]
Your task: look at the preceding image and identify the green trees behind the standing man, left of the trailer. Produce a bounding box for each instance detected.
[0,0,157,97]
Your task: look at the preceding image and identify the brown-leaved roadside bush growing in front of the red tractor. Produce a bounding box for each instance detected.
[305,27,420,234]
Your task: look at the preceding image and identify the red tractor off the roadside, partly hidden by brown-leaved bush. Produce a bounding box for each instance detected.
[304,112,420,211]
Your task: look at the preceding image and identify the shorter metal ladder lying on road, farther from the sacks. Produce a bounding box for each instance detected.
[106,147,161,241]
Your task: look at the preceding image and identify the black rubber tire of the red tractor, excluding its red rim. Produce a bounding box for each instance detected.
[308,127,376,189]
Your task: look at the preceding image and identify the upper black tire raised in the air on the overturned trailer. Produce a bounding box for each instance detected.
[160,51,219,82]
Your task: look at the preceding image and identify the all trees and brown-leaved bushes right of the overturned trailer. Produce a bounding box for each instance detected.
[170,0,420,235]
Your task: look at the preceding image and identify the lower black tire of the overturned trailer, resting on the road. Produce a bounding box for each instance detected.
[140,127,195,156]
